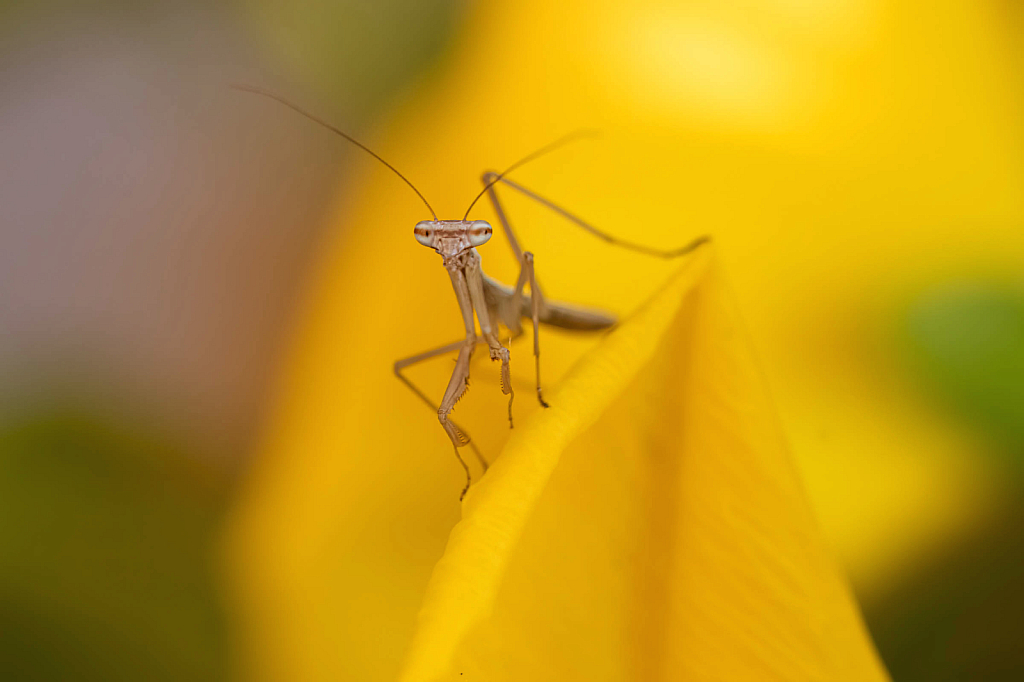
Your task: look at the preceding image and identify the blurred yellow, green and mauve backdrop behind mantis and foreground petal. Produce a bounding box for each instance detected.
[0,0,1024,680]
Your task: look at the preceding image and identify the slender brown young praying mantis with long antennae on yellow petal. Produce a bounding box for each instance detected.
[232,85,710,500]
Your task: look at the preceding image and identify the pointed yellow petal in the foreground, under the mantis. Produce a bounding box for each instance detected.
[400,249,886,682]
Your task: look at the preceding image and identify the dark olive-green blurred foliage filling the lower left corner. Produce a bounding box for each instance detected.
[0,411,227,680]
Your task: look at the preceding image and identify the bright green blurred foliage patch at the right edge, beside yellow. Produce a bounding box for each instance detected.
[906,284,1024,465]
